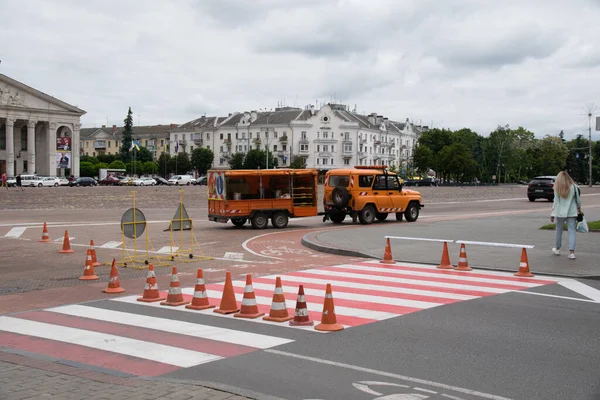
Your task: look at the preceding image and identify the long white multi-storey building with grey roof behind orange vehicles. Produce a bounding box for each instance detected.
[169,104,427,170]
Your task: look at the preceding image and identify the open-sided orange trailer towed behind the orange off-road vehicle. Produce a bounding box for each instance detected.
[207,169,318,229]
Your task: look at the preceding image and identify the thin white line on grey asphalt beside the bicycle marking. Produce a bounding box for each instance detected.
[264,349,511,400]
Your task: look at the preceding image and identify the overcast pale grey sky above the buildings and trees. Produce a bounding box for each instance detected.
[0,0,600,138]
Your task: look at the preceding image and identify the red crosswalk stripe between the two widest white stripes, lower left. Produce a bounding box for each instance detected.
[16,311,257,357]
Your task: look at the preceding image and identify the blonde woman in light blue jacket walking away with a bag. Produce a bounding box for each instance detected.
[550,171,581,260]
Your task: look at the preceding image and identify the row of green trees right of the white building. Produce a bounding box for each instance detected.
[413,125,600,183]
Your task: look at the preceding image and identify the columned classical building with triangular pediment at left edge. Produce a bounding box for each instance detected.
[0,74,85,176]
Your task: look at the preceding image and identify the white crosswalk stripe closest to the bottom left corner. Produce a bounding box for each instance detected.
[0,317,222,368]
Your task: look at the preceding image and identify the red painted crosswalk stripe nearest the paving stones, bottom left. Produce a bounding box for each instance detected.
[0,331,180,376]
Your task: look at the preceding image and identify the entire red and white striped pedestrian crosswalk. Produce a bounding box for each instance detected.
[0,261,555,376]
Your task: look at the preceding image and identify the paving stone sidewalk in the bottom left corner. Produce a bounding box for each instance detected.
[0,351,256,400]
